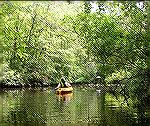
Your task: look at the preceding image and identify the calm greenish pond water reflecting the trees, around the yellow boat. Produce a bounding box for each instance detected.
[0,88,149,126]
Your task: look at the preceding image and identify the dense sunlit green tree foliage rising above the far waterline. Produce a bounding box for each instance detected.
[0,1,150,105]
